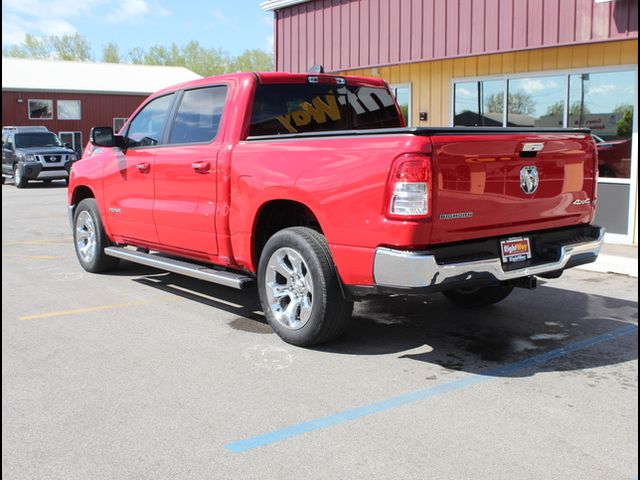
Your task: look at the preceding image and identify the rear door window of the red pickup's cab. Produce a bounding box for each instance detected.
[169,86,227,144]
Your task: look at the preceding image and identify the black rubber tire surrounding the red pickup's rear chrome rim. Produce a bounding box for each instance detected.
[258,227,353,347]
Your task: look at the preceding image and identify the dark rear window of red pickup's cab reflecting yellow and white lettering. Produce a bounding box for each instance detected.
[249,84,403,136]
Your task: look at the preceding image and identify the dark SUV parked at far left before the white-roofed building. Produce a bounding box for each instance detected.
[2,127,78,188]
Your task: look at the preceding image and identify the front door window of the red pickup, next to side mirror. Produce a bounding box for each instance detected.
[126,93,175,148]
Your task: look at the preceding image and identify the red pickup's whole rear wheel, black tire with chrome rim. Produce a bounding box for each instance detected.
[258,227,353,347]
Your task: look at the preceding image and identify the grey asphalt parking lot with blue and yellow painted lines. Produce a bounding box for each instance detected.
[2,182,638,480]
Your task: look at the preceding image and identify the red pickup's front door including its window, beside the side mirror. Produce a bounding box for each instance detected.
[104,93,176,244]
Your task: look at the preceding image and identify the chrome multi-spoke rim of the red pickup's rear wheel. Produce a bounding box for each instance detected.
[265,247,313,330]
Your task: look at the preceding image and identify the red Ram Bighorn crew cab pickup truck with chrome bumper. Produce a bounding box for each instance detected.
[68,73,604,346]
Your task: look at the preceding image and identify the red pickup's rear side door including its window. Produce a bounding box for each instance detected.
[153,85,227,255]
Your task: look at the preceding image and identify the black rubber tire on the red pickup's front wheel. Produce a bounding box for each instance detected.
[73,198,120,273]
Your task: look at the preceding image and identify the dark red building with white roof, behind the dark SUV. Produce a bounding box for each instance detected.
[2,58,201,153]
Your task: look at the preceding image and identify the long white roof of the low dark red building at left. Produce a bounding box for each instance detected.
[2,58,202,95]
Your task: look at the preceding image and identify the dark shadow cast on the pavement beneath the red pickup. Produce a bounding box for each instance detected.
[120,263,638,376]
